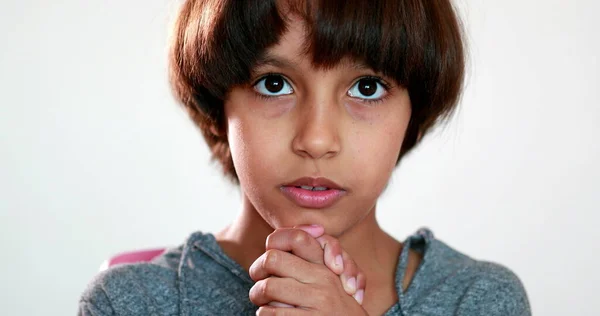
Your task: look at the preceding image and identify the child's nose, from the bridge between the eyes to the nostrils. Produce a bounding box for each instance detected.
[292,95,341,159]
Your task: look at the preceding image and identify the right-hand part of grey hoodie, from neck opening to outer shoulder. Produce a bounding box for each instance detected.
[404,228,531,316]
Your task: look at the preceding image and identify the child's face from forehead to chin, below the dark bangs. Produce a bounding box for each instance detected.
[225,21,411,236]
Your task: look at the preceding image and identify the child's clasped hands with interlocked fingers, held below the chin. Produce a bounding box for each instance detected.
[250,226,366,315]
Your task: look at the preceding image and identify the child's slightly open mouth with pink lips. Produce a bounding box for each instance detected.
[280,178,347,209]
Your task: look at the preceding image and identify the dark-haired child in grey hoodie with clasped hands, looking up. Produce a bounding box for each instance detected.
[79,0,530,315]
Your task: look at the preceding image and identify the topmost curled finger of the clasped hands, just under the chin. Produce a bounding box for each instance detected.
[265,228,323,264]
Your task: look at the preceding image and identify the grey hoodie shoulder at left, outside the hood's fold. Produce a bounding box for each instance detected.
[79,247,182,316]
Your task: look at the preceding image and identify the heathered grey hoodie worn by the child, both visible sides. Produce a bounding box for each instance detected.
[78,229,531,316]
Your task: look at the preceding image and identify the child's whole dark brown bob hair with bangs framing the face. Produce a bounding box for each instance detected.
[169,0,465,182]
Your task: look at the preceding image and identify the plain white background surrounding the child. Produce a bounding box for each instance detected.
[0,0,600,315]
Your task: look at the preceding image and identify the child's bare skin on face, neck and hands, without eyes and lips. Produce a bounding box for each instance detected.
[216,20,421,315]
